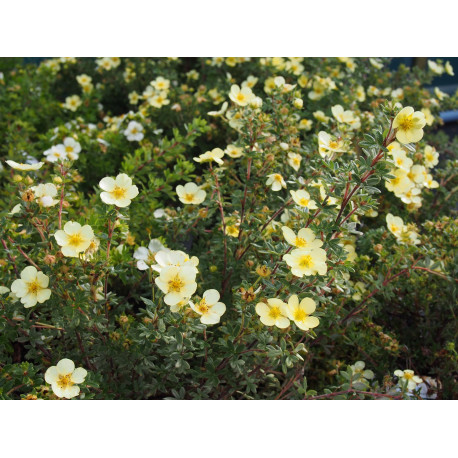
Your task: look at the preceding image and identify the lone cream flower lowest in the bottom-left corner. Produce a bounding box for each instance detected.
[45,358,87,399]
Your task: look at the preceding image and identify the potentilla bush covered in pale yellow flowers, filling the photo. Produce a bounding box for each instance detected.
[0,57,458,399]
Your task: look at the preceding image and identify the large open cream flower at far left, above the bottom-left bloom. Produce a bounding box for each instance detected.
[11,266,51,308]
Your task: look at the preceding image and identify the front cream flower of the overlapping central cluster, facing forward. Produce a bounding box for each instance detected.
[155,264,197,305]
